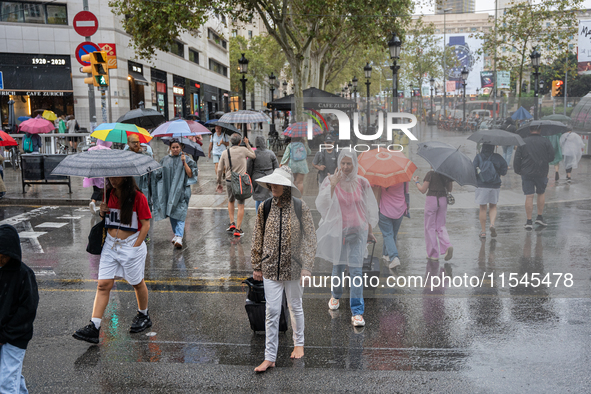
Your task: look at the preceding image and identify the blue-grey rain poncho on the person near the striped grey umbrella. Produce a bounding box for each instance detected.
[152,155,197,221]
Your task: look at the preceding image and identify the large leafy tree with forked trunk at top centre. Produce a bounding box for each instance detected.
[109,0,412,120]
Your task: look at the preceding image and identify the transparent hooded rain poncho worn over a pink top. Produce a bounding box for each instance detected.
[316,149,379,267]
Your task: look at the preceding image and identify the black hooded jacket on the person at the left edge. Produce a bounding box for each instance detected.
[0,224,39,349]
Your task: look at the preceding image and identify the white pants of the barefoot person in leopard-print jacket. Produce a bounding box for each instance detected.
[263,278,304,362]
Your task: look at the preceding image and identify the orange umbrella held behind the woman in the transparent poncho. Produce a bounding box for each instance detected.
[357,149,417,187]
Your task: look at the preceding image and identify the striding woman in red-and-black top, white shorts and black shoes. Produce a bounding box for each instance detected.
[72,177,152,343]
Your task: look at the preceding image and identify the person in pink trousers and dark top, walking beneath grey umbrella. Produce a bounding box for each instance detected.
[413,170,454,261]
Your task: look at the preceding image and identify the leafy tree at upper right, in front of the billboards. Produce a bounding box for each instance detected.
[475,0,583,104]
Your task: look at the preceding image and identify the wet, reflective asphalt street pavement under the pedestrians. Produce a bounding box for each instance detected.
[0,125,591,393]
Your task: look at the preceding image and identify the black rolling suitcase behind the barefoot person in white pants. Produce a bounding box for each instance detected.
[243,278,289,332]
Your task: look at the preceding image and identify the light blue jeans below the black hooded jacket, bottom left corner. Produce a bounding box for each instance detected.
[0,343,29,394]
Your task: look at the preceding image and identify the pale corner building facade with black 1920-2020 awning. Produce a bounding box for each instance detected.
[0,0,230,128]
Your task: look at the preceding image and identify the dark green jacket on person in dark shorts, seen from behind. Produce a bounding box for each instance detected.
[513,134,554,178]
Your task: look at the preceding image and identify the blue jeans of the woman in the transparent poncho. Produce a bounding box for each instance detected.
[332,231,367,316]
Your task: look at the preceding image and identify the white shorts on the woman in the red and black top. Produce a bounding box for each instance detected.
[98,232,148,286]
